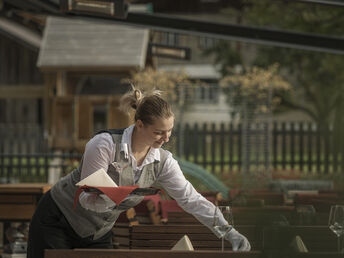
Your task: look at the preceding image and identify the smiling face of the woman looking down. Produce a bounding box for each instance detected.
[136,116,174,148]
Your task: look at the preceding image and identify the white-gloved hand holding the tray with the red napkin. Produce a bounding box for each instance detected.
[79,192,116,213]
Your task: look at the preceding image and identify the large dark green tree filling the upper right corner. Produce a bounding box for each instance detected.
[204,0,344,173]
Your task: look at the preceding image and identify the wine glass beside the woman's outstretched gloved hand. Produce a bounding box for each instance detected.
[213,206,233,252]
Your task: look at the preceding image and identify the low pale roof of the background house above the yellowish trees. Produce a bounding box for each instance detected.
[158,64,221,80]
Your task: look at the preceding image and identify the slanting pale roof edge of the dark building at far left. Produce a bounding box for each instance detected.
[0,17,42,50]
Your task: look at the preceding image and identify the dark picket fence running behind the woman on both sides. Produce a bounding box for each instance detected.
[0,123,344,182]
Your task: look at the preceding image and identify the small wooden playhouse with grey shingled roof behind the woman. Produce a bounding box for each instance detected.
[37,17,149,151]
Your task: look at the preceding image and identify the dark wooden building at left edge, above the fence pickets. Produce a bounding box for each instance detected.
[0,17,43,124]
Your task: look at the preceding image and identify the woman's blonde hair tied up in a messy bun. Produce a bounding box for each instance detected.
[120,86,174,125]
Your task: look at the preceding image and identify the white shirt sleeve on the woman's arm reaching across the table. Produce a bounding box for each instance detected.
[157,154,228,231]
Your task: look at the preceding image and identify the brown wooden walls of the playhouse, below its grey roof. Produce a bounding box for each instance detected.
[50,95,132,152]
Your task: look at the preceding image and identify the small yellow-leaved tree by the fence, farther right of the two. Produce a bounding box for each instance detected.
[220,64,291,179]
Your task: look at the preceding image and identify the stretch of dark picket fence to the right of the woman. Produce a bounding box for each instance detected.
[172,122,344,174]
